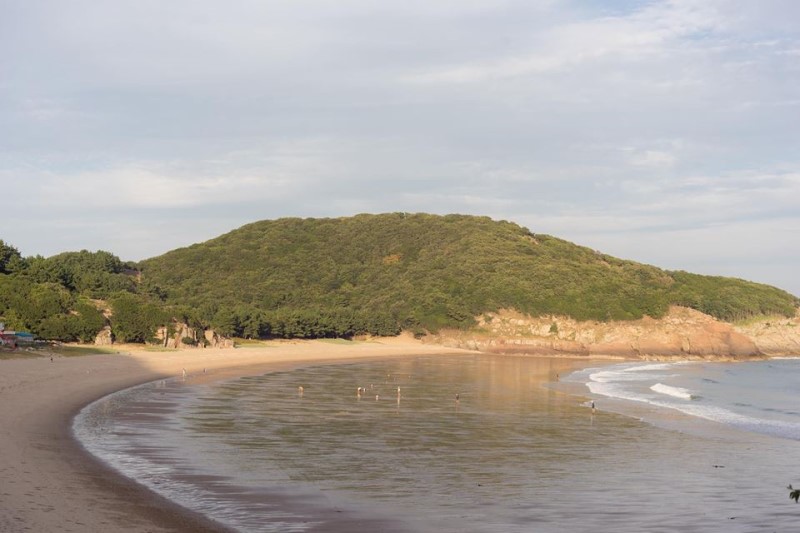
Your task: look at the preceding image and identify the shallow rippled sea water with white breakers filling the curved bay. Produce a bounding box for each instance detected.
[75,355,800,532]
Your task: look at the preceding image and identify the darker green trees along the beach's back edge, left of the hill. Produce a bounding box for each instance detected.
[0,240,400,343]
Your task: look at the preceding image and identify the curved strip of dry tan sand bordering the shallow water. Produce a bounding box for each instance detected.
[0,338,482,533]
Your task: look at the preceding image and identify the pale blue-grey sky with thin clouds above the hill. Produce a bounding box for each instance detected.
[0,0,800,295]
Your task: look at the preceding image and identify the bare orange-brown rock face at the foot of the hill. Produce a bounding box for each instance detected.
[435,307,800,358]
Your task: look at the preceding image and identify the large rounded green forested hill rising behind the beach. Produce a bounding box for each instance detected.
[138,213,798,336]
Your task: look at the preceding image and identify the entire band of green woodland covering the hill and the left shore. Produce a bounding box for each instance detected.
[0,213,799,342]
